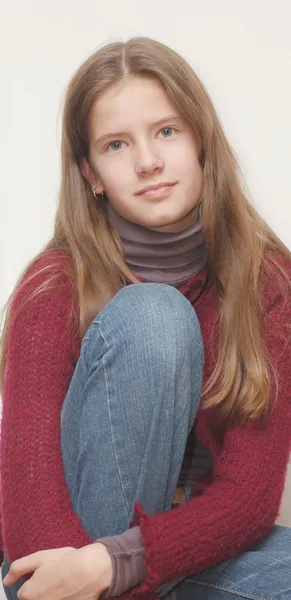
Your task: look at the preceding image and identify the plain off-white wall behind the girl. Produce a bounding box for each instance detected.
[0,0,291,596]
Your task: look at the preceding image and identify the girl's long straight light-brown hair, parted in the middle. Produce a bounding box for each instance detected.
[1,37,291,423]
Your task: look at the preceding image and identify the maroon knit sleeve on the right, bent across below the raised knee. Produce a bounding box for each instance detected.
[126,266,291,597]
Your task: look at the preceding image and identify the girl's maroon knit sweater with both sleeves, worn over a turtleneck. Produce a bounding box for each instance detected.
[1,254,291,598]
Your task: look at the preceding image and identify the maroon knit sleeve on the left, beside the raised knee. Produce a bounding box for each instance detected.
[1,258,90,561]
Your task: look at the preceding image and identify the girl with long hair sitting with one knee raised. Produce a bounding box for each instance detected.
[1,38,291,600]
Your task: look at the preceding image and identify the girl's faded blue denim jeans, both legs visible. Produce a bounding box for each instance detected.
[3,283,291,600]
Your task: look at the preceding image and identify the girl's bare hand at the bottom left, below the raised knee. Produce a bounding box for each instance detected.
[3,542,112,600]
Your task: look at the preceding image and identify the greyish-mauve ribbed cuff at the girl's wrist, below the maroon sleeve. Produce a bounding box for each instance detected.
[95,527,146,599]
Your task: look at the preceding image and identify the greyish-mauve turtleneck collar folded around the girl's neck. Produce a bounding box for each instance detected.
[107,202,207,287]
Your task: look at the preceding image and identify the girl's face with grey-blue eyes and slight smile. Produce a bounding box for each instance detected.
[81,77,203,231]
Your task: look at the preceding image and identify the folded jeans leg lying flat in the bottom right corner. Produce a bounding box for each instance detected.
[167,525,291,600]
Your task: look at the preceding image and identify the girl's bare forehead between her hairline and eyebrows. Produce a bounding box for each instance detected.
[90,77,178,131]
